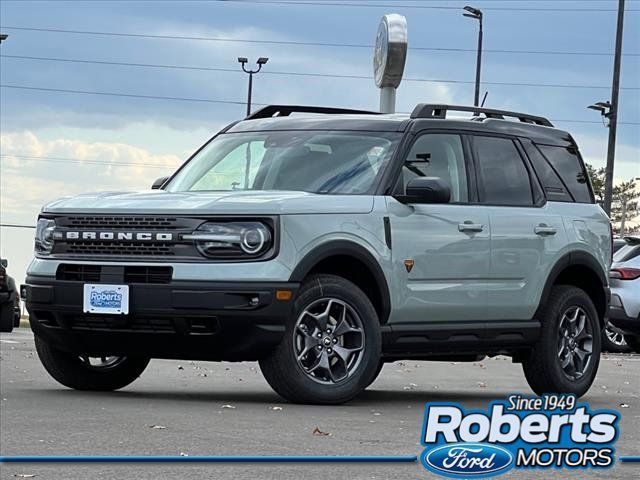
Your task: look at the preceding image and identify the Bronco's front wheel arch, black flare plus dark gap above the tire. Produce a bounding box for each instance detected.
[289,240,391,324]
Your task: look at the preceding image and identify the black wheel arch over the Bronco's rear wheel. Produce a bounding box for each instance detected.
[535,251,609,326]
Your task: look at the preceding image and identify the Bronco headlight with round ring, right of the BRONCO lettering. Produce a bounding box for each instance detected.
[182,222,273,260]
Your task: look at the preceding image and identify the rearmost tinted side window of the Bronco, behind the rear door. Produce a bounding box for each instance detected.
[538,145,593,203]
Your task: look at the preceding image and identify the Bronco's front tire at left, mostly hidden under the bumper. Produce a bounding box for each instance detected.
[35,337,149,391]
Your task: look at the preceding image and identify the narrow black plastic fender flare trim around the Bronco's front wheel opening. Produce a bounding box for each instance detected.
[289,240,391,323]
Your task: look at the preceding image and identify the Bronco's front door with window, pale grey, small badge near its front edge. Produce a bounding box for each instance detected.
[387,133,491,323]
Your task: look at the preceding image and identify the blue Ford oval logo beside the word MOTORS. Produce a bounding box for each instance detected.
[422,443,513,478]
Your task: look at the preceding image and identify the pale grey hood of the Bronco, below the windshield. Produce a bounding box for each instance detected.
[42,190,373,215]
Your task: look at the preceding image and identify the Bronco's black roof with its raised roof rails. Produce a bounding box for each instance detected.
[226,104,575,146]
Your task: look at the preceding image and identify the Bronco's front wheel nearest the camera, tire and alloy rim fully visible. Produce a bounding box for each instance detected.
[260,275,381,405]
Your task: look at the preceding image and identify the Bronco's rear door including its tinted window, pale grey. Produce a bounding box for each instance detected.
[470,134,567,320]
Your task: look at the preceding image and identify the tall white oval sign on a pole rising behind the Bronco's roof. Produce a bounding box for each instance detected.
[373,13,407,113]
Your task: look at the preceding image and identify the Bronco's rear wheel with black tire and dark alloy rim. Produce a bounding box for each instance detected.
[522,285,602,397]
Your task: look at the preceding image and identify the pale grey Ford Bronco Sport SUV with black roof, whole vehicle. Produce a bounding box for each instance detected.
[22,104,612,404]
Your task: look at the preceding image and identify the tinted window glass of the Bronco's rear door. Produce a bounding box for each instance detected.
[472,136,533,206]
